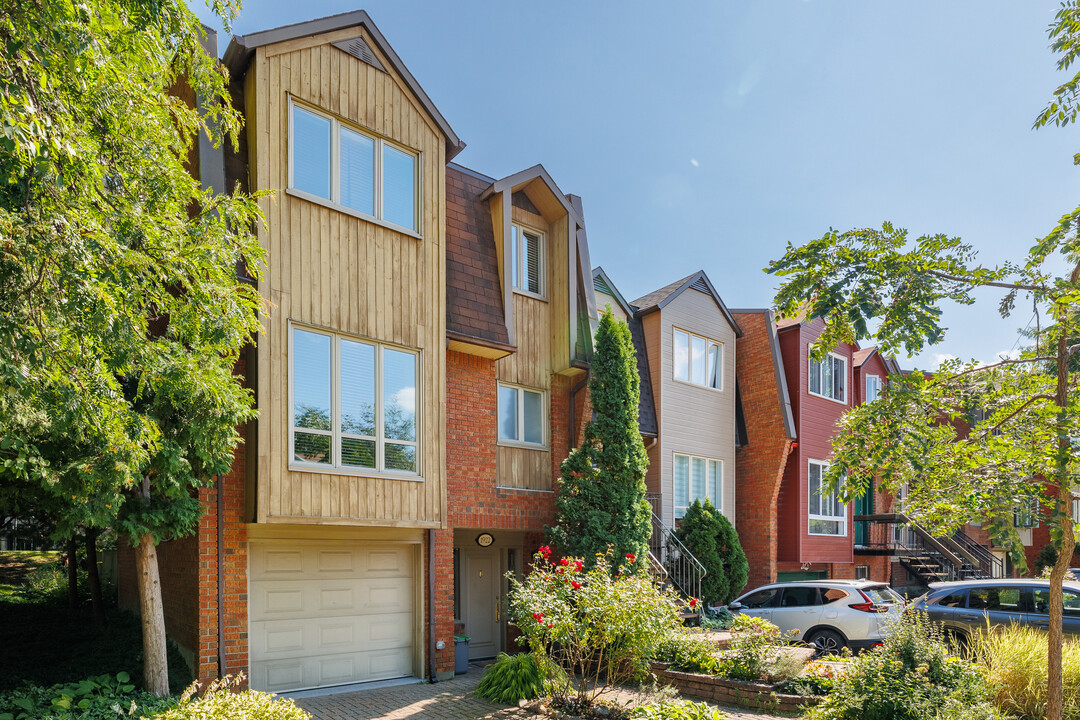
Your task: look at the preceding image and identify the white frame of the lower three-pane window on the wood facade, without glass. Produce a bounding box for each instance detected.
[288,321,423,481]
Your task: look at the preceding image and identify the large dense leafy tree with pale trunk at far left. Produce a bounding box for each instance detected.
[0,0,264,695]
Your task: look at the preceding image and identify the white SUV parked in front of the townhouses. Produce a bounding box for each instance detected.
[728,580,904,653]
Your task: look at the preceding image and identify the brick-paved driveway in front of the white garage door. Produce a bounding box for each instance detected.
[296,667,779,720]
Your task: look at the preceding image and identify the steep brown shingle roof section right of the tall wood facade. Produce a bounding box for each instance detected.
[446,164,510,345]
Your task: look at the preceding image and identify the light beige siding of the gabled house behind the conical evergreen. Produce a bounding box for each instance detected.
[643,288,735,527]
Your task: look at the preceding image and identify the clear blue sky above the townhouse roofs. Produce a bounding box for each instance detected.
[192,0,1080,367]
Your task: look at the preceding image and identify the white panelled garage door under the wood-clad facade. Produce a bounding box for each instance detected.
[248,540,416,692]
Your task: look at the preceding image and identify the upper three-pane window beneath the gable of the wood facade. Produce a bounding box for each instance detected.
[288,99,420,235]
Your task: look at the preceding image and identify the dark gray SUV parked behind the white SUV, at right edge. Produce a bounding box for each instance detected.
[910,579,1080,640]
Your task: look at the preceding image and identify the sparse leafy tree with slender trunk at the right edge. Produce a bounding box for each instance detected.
[768,9,1080,720]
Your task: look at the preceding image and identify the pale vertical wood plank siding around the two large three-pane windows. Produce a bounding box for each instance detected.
[245,27,446,528]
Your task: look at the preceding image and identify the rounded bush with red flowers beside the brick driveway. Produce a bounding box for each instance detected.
[508,545,678,707]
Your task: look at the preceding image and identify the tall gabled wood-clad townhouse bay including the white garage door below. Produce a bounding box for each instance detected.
[121,11,463,691]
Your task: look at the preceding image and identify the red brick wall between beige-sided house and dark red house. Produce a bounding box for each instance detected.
[735,313,792,588]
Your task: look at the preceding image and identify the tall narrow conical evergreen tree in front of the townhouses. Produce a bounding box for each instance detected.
[546,311,652,570]
